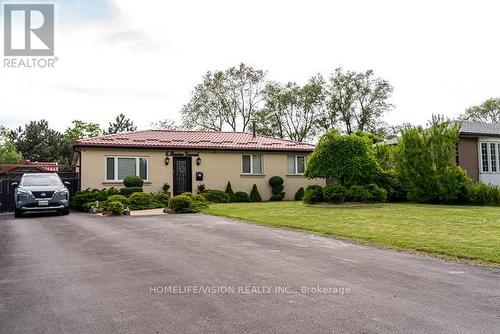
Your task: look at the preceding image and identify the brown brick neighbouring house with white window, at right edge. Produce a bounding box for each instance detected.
[456,122,500,185]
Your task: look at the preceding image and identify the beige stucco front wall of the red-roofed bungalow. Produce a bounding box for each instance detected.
[76,148,325,200]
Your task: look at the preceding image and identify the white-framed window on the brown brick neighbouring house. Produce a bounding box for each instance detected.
[478,138,500,185]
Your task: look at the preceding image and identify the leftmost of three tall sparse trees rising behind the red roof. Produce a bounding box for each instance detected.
[181,64,265,131]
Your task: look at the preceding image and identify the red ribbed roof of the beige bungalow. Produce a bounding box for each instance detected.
[74,130,314,152]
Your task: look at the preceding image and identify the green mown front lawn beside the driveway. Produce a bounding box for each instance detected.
[205,202,500,265]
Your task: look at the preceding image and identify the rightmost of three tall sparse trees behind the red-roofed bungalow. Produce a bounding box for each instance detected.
[318,68,394,134]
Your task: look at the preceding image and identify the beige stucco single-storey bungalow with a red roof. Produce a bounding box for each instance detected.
[73,130,324,200]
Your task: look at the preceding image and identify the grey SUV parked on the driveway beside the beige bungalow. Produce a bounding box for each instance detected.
[12,173,69,217]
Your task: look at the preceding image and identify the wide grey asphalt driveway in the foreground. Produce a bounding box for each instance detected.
[0,214,500,333]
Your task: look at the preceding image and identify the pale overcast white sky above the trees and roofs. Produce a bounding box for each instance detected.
[0,0,500,130]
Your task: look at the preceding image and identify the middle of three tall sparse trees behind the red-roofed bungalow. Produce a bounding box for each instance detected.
[257,76,324,141]
